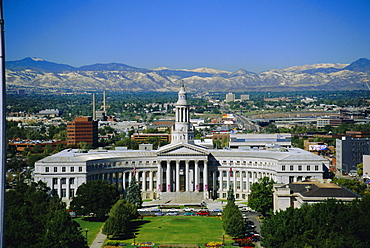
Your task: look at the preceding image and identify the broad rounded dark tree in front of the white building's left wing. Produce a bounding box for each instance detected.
[70,180,119,219]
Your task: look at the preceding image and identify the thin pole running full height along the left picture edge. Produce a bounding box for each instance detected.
[0,0,6,247]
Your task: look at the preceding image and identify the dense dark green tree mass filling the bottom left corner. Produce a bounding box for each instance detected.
[5,181,86,248]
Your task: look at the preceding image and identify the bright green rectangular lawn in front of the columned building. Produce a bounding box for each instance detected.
[110,216,237,245]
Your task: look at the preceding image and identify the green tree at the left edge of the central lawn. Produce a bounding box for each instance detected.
[103,200,138,236]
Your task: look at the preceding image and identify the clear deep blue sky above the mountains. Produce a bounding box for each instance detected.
[3,0,370,72]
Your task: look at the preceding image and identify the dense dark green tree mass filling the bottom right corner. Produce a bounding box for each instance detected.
[261,196,370,248]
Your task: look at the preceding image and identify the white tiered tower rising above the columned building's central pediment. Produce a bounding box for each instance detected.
[171,83,194,144]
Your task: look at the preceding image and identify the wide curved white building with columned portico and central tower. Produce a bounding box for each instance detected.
[34,86,329,202]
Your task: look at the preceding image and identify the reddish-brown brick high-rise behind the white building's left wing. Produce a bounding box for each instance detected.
[67,117,98,147]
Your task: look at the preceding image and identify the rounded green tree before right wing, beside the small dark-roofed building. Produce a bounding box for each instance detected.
[248,177,274,215]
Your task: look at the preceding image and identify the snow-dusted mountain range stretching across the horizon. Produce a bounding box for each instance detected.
[6,57,370,92]
